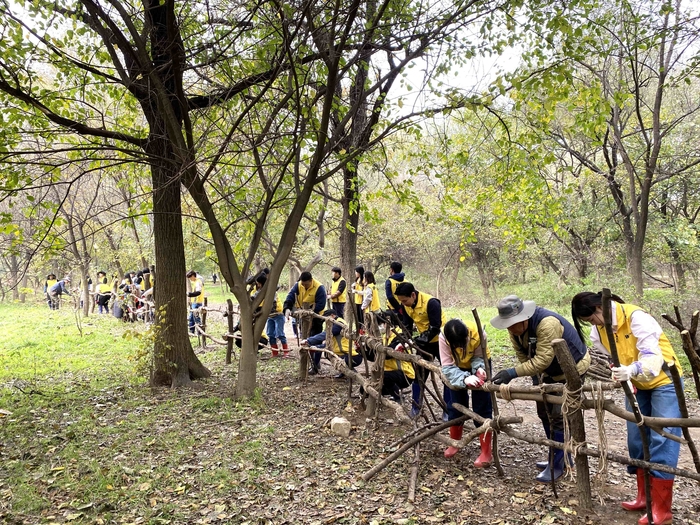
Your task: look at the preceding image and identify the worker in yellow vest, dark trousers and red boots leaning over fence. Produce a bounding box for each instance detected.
[439,319,493,468]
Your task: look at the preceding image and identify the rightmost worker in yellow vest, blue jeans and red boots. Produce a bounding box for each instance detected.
[571,292,682,525]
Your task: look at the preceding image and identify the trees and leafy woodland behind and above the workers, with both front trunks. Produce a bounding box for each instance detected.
[0,0,700,395]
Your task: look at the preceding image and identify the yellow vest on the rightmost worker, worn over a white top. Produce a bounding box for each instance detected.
[596,303,683,390]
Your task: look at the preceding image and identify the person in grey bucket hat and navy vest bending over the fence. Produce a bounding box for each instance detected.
[491,295,591,483]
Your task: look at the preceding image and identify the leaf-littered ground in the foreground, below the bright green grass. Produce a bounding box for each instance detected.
[0,338,700,525]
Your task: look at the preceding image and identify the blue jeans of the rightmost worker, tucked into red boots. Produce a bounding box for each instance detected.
[625,380,681,479]
